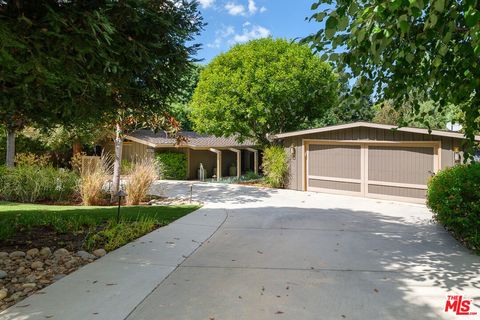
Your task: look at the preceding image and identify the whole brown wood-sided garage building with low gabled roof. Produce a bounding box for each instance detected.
[274,122,480,202]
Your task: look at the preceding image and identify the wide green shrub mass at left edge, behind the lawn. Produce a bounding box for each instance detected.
[0,165,78,202]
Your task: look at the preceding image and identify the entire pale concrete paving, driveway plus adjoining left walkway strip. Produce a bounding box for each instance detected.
[0,183,480,320]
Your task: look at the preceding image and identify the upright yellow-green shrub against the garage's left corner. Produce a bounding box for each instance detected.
[263,146,288,188]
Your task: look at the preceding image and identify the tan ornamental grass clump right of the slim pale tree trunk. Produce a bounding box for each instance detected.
[125,159,158,205]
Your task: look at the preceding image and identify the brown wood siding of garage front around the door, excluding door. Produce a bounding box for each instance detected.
[283,127,463,192]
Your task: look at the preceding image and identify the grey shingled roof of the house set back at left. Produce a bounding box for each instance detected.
[126,130,255,148]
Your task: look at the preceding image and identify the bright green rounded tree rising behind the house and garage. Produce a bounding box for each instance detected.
[192,38,338,145]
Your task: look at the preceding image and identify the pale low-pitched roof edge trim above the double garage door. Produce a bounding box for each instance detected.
[272,121,480,141]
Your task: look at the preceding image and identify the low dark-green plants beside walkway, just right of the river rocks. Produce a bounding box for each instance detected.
[84,218,157,251]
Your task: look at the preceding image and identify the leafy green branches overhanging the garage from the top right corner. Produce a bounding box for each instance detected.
[305,0,480,151]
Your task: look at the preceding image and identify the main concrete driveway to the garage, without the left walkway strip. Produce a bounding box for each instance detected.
[128,184,480,320]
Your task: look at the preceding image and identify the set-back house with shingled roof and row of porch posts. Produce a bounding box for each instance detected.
[103,130,259,180]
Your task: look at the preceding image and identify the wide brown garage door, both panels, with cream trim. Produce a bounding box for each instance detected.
[305,142,437,202]
